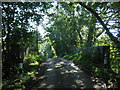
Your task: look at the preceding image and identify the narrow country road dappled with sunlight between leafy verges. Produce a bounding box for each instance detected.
[33,58,103,90]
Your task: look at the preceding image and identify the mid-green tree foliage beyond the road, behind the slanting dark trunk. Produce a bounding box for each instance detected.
[46,2,119,56]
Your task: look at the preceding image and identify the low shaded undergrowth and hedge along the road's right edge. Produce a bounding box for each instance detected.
[63,46,120,86]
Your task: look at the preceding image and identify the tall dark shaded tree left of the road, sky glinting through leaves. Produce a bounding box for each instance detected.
[2,2,42,79]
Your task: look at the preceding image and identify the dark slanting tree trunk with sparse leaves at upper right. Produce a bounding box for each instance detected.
[79,2,119,45]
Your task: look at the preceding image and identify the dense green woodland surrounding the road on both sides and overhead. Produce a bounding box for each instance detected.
[2,2,120,87]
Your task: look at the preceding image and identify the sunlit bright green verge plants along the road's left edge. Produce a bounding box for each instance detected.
[3,53,45,88]
